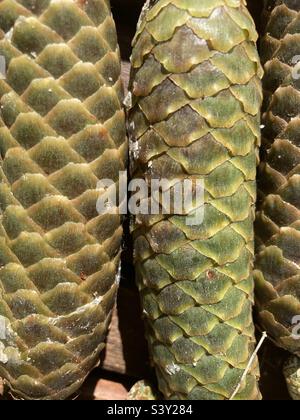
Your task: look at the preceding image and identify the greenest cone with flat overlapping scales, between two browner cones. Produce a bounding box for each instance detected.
[130,0,262,400]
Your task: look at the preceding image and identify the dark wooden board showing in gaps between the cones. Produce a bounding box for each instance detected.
[0,0,289,400]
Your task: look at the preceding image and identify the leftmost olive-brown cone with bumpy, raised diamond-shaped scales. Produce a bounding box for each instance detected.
[0,0,126,399]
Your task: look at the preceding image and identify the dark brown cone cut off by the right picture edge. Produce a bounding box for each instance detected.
[255,1,300,362]
